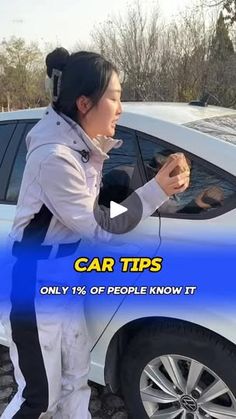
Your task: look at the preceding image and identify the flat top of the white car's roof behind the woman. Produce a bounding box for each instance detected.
[0,102,236,124]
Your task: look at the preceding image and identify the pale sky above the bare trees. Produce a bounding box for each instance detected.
[0,0,192,49]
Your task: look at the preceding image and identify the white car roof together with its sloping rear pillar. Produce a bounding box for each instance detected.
[0,102,236,175]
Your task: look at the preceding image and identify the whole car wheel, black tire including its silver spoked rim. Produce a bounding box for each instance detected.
[120,319,236,419]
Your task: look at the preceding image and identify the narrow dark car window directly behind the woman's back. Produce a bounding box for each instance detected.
[6,123,35,203]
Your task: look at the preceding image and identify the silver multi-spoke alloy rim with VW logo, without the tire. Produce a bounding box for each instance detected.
[140,355,236,419]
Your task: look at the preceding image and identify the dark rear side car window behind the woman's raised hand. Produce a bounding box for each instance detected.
[139,134,236,218]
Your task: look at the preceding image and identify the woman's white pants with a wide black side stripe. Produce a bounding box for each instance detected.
[1,253,91,419]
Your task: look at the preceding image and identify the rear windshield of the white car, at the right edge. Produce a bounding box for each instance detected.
[184,113,236,145]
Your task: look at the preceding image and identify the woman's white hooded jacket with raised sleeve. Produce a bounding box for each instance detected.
[11,106,168,244]
